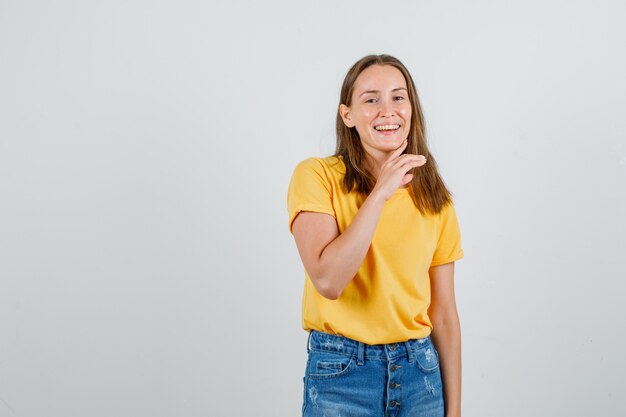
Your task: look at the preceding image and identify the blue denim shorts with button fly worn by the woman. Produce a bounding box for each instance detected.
[302,330,444,417]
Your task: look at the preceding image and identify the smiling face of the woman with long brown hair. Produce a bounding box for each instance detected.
[339,65,411,157]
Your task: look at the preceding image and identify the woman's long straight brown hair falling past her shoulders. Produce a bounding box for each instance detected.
[334,54,452,214]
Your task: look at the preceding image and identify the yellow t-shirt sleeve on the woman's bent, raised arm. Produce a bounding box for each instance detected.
[287,158,336,233]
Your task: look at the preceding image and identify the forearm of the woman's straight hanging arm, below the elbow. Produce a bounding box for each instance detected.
[431,314,461,417]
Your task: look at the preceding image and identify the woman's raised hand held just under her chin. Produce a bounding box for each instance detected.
[372,140,426,201]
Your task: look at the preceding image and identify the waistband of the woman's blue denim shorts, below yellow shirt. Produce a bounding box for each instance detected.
[307,330,432,364]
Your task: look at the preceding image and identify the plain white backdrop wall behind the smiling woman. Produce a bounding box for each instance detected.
[0,0,626,417]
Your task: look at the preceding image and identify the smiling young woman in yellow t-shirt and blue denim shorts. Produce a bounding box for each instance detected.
[287,55,463,417]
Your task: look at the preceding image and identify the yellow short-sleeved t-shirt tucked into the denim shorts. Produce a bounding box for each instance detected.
[287,156,463,345]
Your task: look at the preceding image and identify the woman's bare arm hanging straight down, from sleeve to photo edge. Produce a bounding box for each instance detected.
[428,262,461,417]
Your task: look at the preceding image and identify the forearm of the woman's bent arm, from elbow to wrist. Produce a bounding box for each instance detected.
[319,193,385,298]
